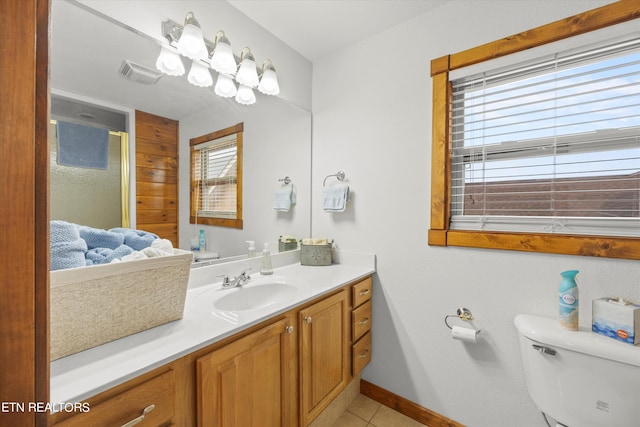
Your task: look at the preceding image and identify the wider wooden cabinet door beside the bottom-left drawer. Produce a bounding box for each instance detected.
[196,319,297,427]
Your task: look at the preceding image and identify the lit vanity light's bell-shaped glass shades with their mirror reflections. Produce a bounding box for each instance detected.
[156,12,280,105]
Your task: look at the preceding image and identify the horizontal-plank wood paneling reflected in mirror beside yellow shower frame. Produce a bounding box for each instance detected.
[136,111,178,248]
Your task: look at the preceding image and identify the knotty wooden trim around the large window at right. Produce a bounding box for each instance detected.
[428,0,640,260]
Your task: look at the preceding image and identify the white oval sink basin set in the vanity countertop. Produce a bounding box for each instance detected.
[213,277,305,311]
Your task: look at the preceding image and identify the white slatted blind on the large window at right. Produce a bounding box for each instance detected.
[451,33,640,236]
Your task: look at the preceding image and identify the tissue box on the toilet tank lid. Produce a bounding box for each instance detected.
[591,298,640,345]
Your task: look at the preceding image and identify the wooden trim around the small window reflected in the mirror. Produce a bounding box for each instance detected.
[189,123,244,229]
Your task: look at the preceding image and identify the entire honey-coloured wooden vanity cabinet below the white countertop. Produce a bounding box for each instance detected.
[50,277,372,427]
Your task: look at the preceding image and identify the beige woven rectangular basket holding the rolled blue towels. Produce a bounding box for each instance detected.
[50,249,193,360]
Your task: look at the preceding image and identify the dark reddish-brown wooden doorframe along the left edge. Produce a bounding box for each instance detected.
[0,0,51,426]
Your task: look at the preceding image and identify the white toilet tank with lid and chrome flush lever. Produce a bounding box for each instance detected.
[515,314,640,427]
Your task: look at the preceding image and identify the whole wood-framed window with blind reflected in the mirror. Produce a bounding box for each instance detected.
[190,123,244,229]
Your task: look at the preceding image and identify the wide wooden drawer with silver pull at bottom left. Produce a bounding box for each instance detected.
[54,370,175,427]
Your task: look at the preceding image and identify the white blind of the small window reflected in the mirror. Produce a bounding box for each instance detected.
[193,134,238,219]
